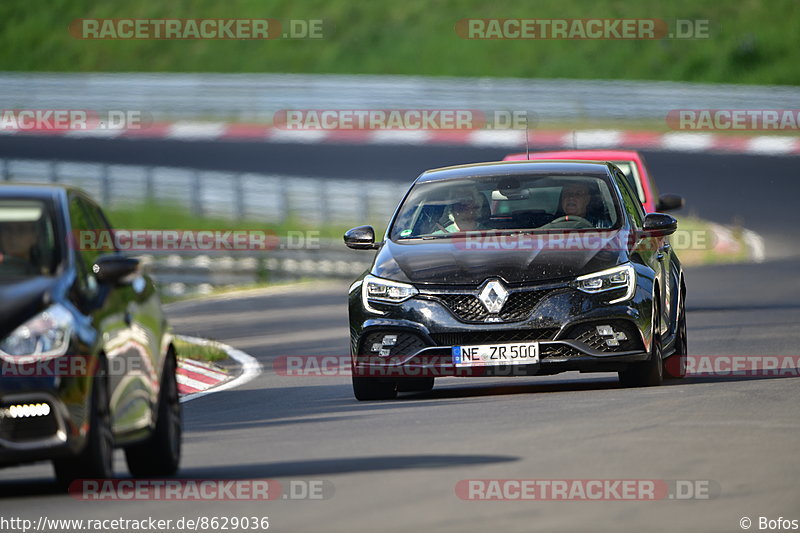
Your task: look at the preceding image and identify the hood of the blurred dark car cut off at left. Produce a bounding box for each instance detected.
[0,276,58,339]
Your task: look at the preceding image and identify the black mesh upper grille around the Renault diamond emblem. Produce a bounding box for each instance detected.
[432,289,563,323]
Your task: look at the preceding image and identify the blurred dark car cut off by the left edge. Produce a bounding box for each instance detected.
[0,185,181,486]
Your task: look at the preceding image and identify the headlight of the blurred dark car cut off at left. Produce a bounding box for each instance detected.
[0,304,72,358]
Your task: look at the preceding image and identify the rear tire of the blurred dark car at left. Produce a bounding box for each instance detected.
[125,352,182,477]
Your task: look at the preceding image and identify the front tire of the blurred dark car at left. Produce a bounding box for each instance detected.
[53,358,114,490]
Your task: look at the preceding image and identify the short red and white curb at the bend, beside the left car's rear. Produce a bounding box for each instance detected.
[177,335,261,403]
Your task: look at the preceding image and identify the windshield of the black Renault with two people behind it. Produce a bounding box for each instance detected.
[389,175,619,240]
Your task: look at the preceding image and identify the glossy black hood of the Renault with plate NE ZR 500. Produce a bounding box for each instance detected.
[372,231,628,285]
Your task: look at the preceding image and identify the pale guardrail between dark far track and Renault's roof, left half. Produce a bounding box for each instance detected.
[0,159,406,226]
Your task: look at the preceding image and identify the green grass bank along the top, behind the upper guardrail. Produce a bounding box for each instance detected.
[0,0,800,85]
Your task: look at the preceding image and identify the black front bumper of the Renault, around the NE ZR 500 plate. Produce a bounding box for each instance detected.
[350,284,652,377]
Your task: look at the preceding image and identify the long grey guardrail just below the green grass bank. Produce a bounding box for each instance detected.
[0,72,800,122]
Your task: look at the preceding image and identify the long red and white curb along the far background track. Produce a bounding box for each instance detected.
[0,121,800,155]
